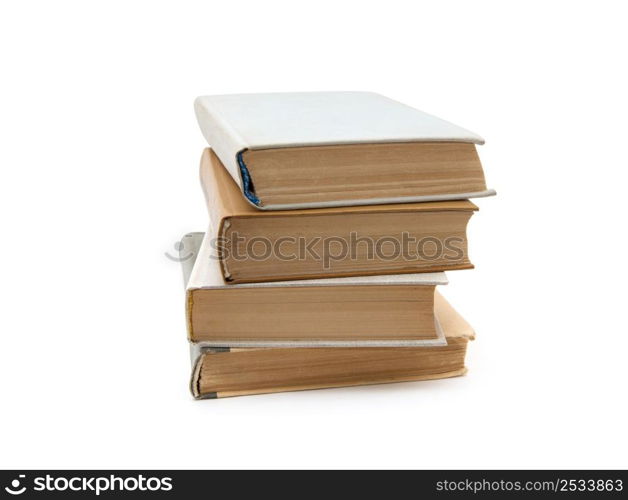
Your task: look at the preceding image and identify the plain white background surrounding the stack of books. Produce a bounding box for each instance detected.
[0,0,628,469]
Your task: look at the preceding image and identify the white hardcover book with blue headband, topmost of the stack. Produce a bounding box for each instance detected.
[194,92,495,210]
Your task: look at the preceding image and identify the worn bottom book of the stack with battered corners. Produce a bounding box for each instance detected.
[180,233,475,399]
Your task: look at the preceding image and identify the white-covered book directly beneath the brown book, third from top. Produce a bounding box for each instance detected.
[180,230,447,347]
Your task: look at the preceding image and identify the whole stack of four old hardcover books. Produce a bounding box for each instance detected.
[180,92,494,399]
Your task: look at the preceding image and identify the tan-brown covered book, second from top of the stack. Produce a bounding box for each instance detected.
[200,148,478,283]
